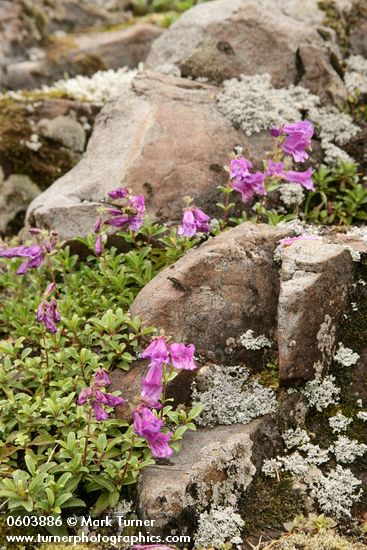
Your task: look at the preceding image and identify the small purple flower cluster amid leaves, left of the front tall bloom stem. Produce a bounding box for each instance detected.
[77,369,125,420]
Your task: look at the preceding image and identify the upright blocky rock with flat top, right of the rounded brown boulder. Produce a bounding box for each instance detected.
[277,241,353,382]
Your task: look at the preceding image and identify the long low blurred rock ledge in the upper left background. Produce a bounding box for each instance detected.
[3,24,162,89]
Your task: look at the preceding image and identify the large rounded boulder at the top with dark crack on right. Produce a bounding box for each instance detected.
[147,0,346,99]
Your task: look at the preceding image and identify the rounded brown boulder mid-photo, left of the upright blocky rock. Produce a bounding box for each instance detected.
[131,223,289,358]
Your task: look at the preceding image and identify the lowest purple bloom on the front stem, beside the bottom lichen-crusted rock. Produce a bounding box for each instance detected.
[134,407,173,458]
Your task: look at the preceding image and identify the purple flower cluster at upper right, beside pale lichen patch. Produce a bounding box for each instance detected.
[229,120,314,202]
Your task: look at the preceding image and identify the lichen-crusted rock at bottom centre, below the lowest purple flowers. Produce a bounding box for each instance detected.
[138,396,307,535]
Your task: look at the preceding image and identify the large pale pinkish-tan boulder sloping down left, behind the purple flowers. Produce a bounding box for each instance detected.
[28,72,271,238]
